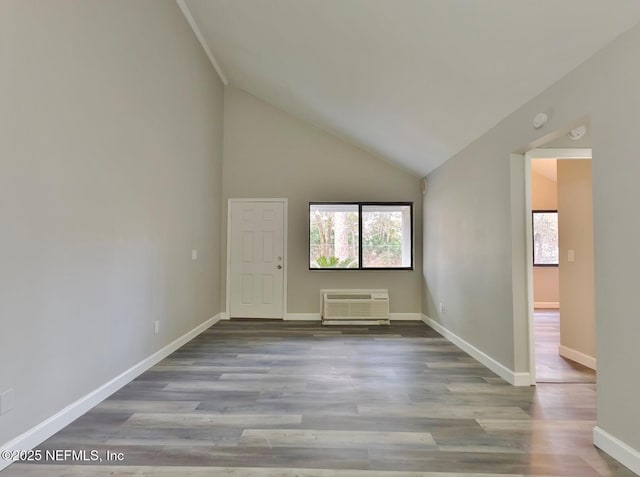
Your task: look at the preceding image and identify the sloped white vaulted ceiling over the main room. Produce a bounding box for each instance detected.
[178,0,640,175]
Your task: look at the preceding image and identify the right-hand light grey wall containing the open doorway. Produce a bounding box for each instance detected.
[423,21,640,458]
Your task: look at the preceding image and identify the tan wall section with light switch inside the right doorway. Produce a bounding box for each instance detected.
[558,159,606,364]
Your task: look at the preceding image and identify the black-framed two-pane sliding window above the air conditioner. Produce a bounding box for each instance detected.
[309,202,413,270]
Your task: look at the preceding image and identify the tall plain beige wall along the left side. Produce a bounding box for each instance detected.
[0,0,223,448]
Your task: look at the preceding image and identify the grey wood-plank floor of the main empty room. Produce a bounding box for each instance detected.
[2,320,634,477]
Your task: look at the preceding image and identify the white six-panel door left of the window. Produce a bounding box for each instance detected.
[228,199,286,318]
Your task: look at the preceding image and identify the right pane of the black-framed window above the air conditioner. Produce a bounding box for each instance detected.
[362,205,412,268]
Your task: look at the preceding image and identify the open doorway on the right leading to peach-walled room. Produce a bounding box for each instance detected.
[525,148,596,384]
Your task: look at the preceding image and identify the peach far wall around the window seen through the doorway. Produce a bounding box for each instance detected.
[531,167,560,308]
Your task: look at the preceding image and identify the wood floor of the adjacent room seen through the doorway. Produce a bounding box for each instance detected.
[534,310,596,383]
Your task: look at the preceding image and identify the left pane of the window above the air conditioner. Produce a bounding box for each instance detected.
[309,204,359,268]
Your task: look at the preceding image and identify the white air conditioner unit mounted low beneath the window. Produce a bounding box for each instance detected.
[320,289,389,325]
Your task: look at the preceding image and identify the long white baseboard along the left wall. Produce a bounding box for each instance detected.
[0,313,223,471]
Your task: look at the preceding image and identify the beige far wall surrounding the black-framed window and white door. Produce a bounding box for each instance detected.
[223,88,422,313]
